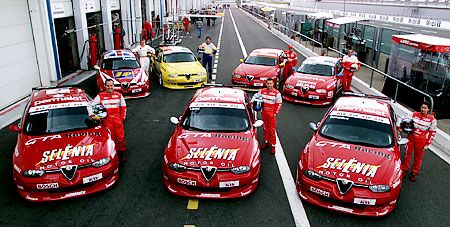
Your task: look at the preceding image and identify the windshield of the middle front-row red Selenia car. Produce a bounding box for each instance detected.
[181,107,250,132]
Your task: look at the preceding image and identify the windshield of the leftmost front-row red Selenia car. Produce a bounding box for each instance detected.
[24,106,96,136]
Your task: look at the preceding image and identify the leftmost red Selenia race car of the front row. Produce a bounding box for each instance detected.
[10,87,119,202]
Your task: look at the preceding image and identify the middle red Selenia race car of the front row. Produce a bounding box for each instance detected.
[162,87,262,199]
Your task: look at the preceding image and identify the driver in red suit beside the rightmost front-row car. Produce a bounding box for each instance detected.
[401,102,437,182]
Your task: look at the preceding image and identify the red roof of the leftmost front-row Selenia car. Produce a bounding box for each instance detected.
[30,87,89,109]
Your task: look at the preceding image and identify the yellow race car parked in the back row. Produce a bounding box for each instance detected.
[153,46,207,89]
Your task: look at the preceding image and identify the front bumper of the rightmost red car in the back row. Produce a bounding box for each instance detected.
[281,87,335,106]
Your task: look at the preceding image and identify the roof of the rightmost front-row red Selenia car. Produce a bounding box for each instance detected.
[333,96,390,118]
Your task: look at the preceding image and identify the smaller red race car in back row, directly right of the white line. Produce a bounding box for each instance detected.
[231,49,285,87]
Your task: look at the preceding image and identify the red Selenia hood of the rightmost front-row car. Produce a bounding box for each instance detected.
[305,136,400,185]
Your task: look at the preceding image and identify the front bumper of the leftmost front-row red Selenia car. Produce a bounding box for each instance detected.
[14,164,119,202]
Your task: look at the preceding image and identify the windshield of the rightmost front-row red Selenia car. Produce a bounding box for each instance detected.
[320,115,394,147]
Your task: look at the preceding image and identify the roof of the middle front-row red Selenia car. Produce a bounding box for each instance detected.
[192,87,245,104]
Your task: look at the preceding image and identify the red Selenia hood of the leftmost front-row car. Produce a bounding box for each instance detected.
[15,126,114,170]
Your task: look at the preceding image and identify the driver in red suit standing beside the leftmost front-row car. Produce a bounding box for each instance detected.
[91,79,127,162]
